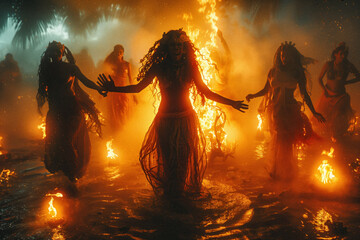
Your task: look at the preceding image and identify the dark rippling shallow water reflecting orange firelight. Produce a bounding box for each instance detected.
[0,136,360,239]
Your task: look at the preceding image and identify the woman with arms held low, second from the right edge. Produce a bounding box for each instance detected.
[246,42,325,180]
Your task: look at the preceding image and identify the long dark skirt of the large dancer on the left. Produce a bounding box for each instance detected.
[44,108,91,181]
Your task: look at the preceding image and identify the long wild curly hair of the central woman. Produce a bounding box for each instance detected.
[137,29,204,103]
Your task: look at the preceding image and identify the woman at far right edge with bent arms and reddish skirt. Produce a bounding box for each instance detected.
[317,42,360,138]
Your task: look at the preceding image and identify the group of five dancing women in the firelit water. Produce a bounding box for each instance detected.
[37,29,360,202]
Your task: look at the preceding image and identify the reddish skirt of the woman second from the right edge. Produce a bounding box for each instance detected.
[269,102,317,180]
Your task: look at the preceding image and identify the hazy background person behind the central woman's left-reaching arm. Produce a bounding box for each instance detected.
[104,44,132,130]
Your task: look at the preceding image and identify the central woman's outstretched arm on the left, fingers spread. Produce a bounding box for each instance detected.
[97,68,155,93]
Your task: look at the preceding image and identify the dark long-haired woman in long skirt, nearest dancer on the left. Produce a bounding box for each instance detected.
[36,41,104,182]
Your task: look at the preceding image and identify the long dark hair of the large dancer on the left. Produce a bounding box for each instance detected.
[36,41,102,136]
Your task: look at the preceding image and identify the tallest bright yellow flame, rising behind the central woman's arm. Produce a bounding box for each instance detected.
[183,0,231,152]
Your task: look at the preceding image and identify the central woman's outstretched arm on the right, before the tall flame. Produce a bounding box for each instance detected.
[193,63,248,112]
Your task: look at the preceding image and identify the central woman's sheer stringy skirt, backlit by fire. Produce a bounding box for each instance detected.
[140,110,207,198]
